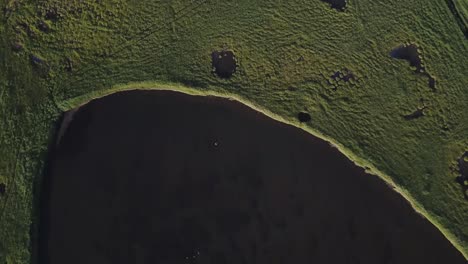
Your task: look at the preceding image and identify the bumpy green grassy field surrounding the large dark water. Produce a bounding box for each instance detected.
[0,0,468,264]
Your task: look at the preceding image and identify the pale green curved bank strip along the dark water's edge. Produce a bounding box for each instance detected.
[57,82,468,260]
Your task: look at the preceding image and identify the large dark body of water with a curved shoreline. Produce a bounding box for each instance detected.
[39,91,466,264]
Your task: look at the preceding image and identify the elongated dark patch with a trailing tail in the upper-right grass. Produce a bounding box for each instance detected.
[390,44,436,90]
